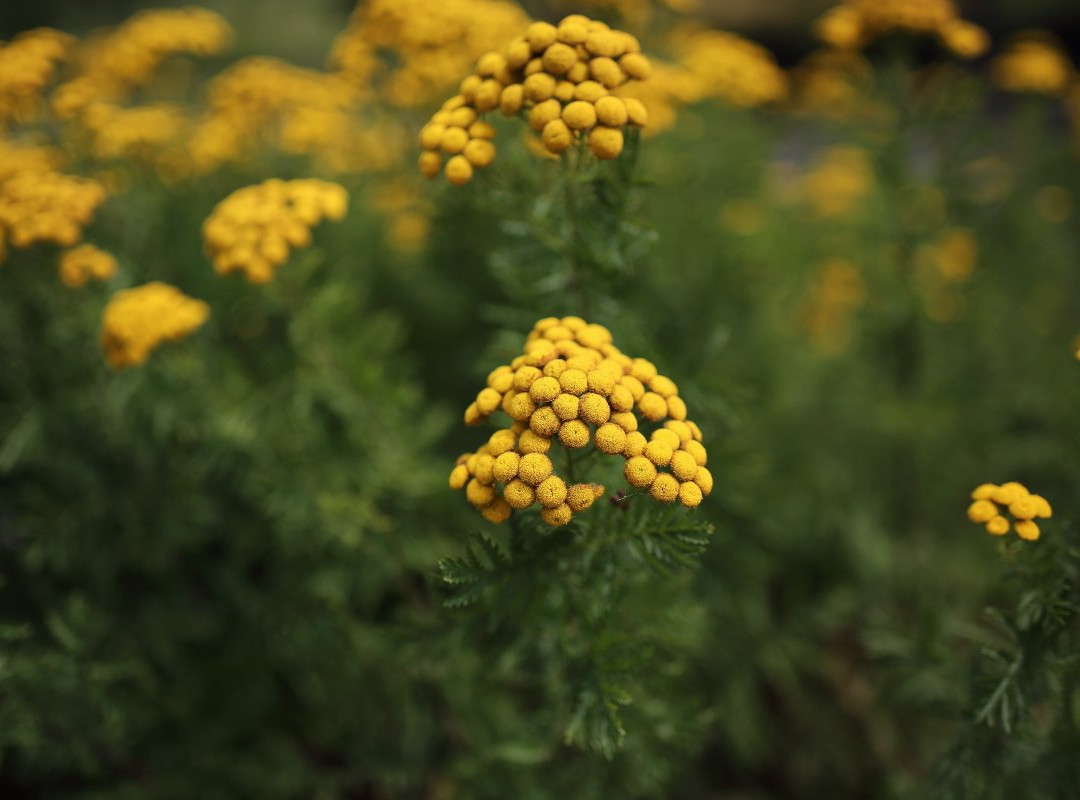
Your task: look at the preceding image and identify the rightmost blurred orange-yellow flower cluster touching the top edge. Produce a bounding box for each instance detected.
[814,0,990,58]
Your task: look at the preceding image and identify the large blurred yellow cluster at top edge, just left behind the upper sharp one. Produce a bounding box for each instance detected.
[330,0,529,106]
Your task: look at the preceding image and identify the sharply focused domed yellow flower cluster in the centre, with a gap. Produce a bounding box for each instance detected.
[449,316,713,526]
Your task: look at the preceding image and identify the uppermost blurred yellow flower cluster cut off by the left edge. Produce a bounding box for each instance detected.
[0,28,73,123]
